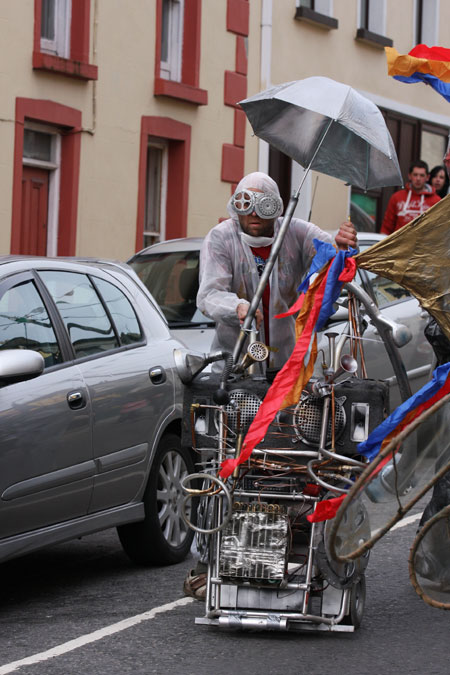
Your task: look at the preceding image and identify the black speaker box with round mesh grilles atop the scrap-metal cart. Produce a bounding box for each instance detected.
[182,373,389,456]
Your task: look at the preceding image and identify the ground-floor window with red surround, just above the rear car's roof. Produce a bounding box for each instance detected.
[136,117,191,251]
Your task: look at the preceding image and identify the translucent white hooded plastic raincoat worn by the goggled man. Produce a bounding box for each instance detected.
[197,172,332,369]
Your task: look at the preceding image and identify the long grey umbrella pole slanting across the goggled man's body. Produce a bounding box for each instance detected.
[233,119,334,365]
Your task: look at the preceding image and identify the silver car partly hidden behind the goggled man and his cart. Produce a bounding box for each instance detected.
[129,232,433,408]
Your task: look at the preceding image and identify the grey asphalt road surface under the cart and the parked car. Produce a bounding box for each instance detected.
[0,508,450,675]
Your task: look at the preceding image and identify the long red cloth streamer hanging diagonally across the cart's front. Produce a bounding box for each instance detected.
[220,268,330,478]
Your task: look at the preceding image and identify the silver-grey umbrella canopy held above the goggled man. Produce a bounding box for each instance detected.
[240,77,403,189]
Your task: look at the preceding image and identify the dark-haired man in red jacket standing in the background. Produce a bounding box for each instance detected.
[380,160,440,234]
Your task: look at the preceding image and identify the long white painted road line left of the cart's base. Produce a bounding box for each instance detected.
[0,598,194,675]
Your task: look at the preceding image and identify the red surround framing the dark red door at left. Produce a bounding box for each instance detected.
[11,98,81,255]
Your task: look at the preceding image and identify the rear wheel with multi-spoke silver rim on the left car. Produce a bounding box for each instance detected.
[117,434,197,565]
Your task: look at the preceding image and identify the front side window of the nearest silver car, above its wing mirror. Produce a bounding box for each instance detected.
[0,281,62,367]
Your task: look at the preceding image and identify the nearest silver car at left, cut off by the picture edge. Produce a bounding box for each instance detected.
[0,256,194,564]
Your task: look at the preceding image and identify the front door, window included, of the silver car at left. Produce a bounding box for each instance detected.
[0,272,95,538]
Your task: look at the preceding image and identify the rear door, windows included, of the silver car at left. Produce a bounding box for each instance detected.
[38,272,178,512]
